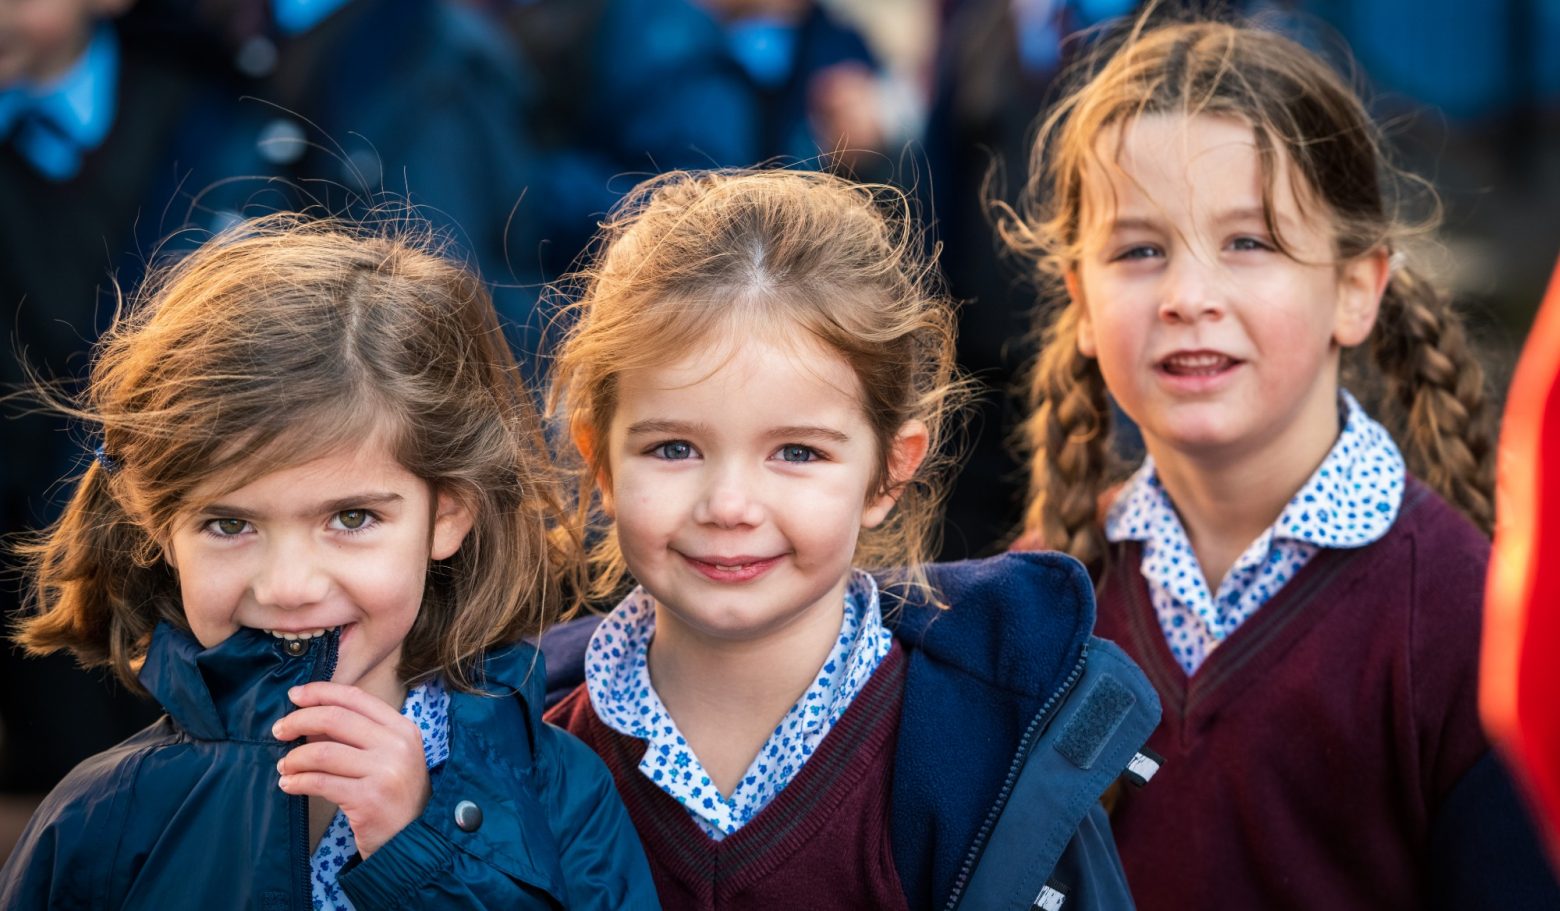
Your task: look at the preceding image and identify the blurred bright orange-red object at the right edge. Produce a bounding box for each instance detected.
[1479,252,1560,869]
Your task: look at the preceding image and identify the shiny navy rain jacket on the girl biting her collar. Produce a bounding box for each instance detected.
[0,624,658,911]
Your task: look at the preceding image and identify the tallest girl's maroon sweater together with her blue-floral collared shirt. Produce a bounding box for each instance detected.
[1098,393,1560,911]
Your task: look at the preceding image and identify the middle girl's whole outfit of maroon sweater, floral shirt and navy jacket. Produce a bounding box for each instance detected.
[543,554,1159,909]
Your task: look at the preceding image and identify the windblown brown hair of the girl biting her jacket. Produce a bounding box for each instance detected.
[17,215,568,688]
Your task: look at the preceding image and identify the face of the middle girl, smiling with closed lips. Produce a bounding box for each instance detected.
[601,339,902,641]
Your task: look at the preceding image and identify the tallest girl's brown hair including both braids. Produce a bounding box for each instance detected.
[1000,14,1493,569]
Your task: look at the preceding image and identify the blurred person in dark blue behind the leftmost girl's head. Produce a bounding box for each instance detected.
[131,0,546,373]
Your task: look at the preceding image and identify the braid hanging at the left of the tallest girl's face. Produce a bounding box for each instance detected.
[1023,304,1111,572]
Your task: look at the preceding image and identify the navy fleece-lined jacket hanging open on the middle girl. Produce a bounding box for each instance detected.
[541,552,1159,911]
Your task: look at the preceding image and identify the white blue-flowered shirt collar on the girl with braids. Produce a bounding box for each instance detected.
[1104,392,1404,675]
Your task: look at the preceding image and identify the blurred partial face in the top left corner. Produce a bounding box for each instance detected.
[0,0,129,86]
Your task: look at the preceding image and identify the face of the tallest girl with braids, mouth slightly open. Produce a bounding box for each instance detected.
[1069,114,1387,462]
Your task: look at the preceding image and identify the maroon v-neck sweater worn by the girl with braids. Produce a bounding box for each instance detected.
[1095,479,1488,911]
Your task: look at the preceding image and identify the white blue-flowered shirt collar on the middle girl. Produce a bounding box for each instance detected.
[585,572,894,841]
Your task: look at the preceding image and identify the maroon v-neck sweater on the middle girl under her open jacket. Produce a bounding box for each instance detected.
[546,643,908,911]
